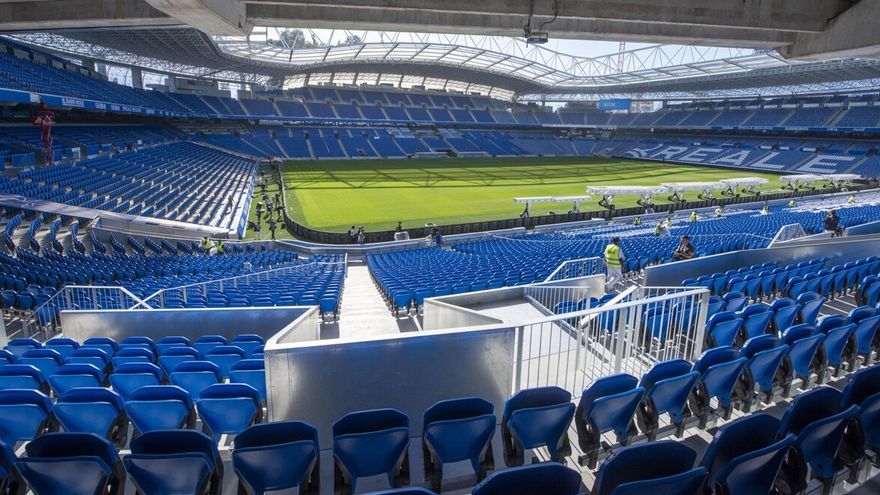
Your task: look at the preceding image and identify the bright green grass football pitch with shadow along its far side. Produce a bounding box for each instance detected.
[251,158,780,236]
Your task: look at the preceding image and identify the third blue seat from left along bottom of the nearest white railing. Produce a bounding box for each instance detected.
[636,359,700,440]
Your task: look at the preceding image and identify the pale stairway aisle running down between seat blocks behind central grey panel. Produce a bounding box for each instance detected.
[339,261,415,338]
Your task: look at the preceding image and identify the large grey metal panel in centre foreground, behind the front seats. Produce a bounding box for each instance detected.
[266,327,516,449]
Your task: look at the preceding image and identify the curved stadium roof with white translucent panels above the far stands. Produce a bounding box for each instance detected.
[11,27,880,100]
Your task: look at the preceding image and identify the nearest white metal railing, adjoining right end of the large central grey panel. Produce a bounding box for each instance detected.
[514,288,709,397]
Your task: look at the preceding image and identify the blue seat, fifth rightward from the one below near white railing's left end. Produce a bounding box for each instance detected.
[740,335,792,411]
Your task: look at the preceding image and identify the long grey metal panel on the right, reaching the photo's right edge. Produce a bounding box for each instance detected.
[645,237,880,286]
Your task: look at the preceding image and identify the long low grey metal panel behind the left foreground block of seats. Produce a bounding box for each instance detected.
[61,306,314,342]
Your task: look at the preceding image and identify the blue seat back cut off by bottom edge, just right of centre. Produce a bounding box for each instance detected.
[472,462,583,495]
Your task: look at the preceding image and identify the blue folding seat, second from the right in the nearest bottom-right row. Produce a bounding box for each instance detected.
[777,386,864,493]
